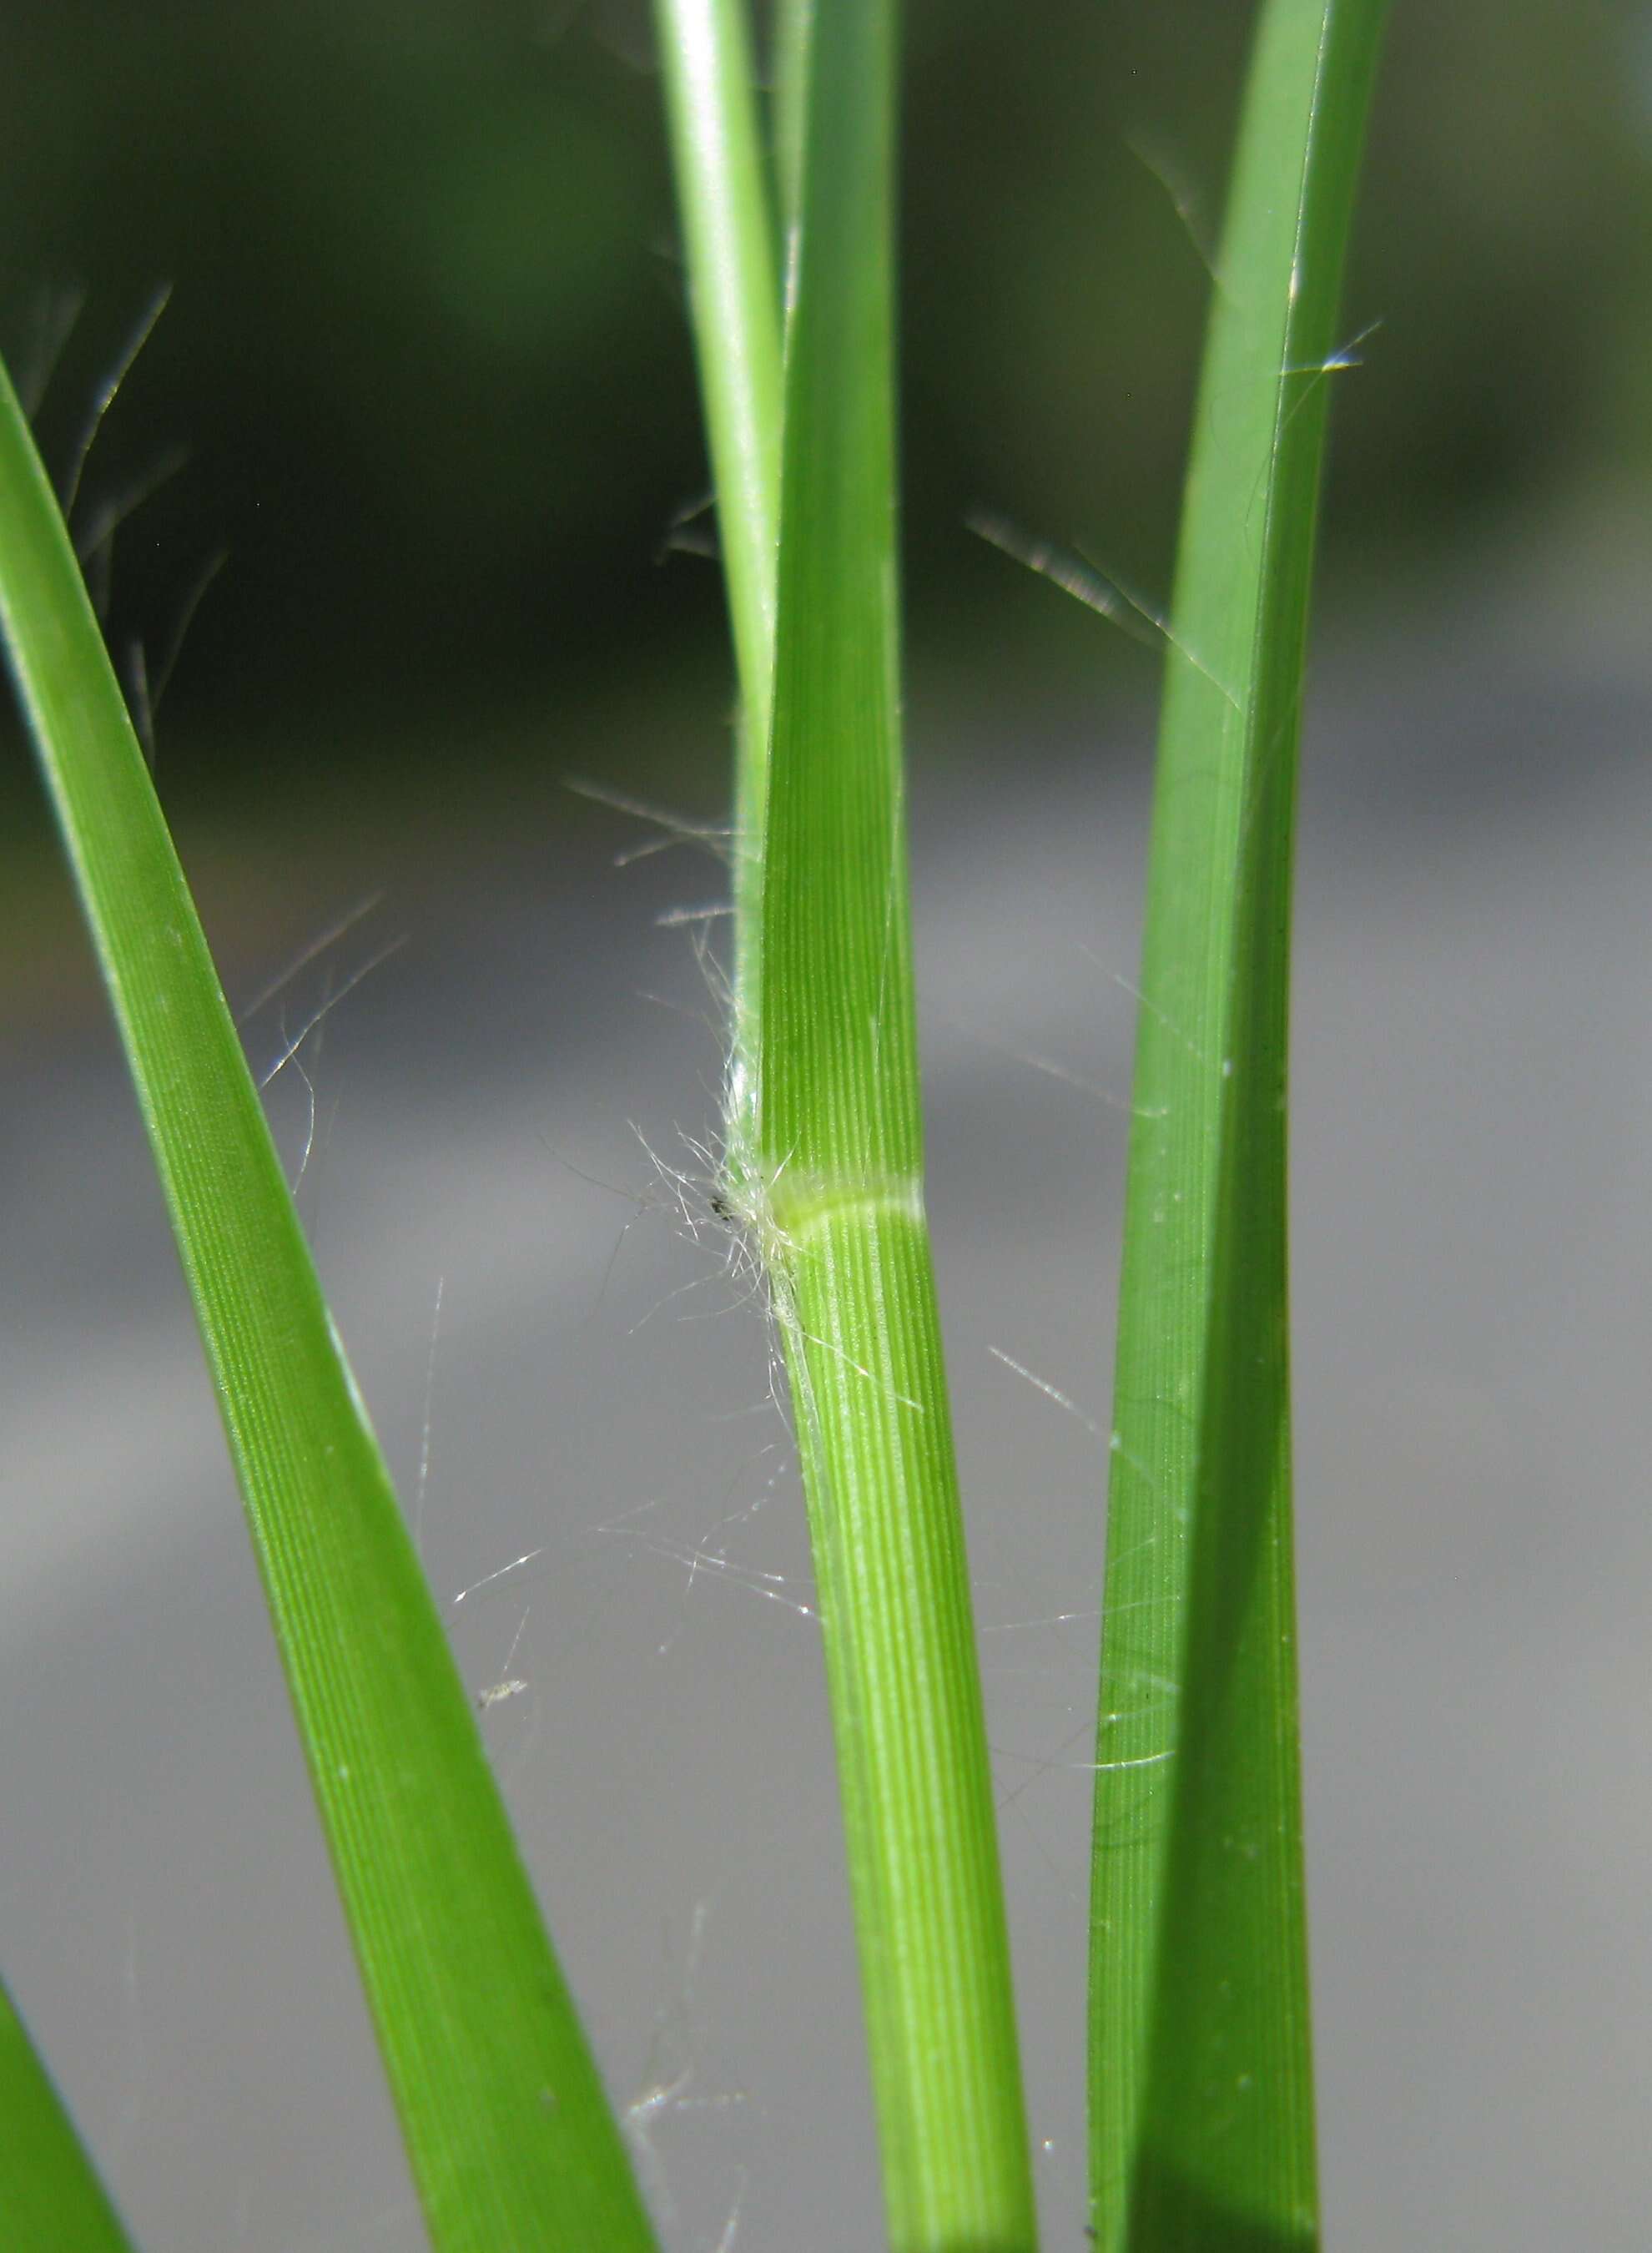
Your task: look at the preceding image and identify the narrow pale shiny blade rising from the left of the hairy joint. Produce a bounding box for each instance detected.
[653,0,780,1138]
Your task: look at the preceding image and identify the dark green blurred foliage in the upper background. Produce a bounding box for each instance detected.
[0,0,1652,829]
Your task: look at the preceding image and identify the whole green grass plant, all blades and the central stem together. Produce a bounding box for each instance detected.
[0,0,1384,2253]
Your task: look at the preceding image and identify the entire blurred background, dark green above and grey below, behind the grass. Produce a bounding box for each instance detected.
[0,0,1652,2253]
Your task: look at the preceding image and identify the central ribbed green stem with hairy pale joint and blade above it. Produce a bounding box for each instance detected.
[748,0,1035,2253]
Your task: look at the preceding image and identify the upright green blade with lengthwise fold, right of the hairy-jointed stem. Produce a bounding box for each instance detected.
[1090,0,1384,2253]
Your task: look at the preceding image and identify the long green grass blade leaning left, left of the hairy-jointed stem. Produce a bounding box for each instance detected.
[0,372,652,2253]
